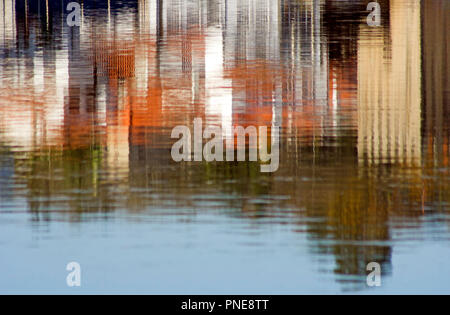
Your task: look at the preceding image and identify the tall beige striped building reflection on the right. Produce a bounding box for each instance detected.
[358,0,421,165]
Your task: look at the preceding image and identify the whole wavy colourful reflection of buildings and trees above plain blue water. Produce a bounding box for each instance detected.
[0,0,450,289]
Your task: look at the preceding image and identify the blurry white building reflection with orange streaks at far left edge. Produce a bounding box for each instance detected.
[0,1,69,148]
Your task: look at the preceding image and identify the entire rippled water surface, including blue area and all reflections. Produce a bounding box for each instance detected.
[0,0,450,294]
